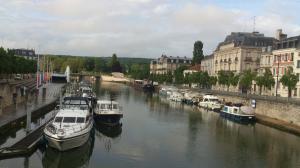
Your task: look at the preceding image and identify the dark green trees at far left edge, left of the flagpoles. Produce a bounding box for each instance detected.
[0,47,36,74]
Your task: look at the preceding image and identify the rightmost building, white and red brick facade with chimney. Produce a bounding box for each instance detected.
[272,30,300,97]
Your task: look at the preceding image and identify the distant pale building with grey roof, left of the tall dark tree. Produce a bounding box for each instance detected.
[150,55,192,74]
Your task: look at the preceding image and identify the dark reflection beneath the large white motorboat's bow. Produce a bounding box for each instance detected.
[42,130,95,168]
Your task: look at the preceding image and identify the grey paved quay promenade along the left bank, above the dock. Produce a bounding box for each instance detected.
[0,83,64,128]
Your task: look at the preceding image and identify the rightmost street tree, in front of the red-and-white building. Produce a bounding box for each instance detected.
[280,67,299,97]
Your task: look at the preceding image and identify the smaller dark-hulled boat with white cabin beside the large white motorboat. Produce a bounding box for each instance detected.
[94,100,123,125]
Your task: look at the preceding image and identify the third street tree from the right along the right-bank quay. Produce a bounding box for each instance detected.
[240,69,256,93]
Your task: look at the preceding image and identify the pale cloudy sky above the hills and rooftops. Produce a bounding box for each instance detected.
[0,0,300,58]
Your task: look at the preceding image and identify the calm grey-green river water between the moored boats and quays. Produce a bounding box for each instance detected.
[0,83,300,168]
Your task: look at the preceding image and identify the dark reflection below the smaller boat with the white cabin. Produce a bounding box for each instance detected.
[95,123,122,138]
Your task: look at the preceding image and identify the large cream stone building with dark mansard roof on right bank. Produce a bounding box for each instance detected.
[214,32,275,75]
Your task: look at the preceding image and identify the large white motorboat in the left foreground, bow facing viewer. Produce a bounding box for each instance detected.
[44,97,93,151]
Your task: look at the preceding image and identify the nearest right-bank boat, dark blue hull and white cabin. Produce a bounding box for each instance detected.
[220,103,255,123]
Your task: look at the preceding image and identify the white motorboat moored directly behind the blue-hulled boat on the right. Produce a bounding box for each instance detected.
[198,94,223,110]
